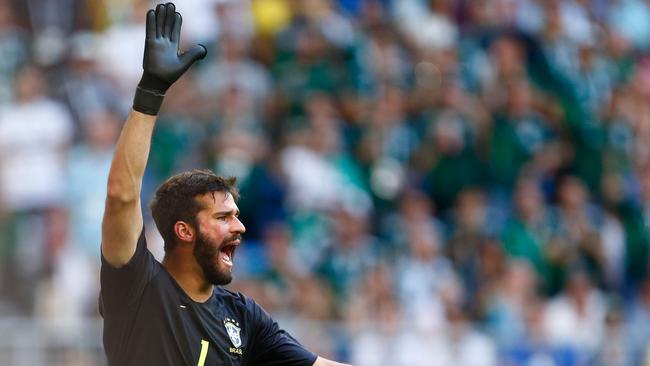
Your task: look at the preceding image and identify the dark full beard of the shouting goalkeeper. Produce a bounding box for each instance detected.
[194,231,241,286]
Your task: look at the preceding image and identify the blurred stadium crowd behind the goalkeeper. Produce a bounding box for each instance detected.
[0,0,650,366]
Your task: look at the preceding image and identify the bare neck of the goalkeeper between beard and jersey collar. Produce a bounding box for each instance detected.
[162,253,213,303]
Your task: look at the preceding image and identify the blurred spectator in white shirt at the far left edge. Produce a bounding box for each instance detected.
[0,65,74,313]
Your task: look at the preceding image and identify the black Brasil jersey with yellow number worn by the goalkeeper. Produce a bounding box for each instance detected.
[99,230,316,366]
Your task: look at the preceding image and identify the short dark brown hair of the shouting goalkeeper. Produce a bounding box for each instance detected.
[150,169,239,252]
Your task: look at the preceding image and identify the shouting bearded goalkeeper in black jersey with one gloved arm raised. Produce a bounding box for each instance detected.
[99,3,350,366]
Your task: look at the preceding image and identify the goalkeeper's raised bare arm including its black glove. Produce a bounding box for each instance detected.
[102,3,206,267]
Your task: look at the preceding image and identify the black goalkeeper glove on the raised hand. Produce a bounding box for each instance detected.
[133,3,207,116]
